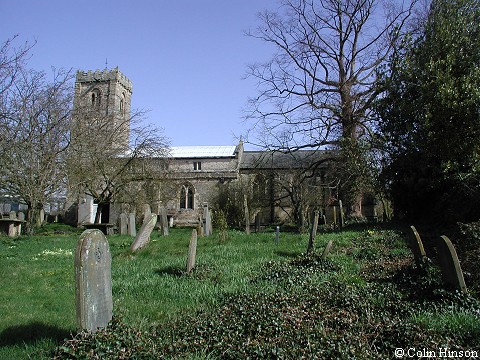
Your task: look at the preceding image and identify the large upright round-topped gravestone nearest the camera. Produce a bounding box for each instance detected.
[75,229,113,332]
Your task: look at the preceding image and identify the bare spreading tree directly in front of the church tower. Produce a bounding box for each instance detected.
[68,106,169,223]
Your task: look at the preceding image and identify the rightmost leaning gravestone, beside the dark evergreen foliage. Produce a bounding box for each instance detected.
[437,235,467,292]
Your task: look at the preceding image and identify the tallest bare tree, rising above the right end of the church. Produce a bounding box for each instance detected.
[247,0,414,213]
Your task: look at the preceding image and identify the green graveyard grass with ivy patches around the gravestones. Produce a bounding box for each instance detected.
[0,224,480,359]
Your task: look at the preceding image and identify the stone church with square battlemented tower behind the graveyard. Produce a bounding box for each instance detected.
[68,68,344,226]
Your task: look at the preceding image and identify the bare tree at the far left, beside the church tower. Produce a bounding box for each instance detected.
[0,68,72,229]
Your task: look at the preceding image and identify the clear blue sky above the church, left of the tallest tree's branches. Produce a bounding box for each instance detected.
[0,0,278,146]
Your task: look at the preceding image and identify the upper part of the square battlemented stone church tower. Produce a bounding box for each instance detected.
[74,68,132,147]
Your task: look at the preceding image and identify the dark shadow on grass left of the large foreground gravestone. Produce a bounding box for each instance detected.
[0,322,70,346]
